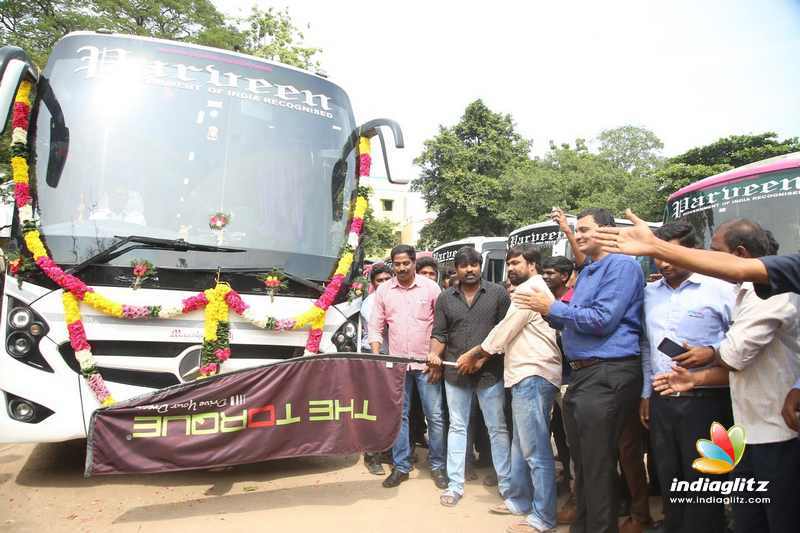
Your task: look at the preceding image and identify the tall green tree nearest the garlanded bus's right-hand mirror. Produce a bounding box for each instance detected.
[412,100,531,247]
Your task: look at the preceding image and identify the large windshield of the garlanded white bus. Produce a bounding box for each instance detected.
[34,34,356,280]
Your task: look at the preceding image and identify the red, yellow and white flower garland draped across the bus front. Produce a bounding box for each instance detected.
[11,81,371,406]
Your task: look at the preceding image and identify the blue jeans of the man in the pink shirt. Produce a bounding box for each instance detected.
[392,370,444,474]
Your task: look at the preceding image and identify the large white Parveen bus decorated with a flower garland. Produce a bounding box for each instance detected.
[0,32,402,442]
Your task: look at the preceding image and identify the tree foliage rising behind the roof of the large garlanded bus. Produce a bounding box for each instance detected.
[0,0,319,68]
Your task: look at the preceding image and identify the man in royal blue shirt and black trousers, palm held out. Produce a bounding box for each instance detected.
[514,208,644,533]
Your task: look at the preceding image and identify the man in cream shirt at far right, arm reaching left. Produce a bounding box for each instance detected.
[654,219,800,533]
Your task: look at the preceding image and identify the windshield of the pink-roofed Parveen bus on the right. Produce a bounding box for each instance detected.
[664,168,800,254]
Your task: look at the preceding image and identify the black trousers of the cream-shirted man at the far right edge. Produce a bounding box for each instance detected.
[729,436,800,533]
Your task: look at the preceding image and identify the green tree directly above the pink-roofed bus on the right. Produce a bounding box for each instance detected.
[656,131,800,196]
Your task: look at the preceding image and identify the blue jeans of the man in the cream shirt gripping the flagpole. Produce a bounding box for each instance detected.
[506,376,558,530]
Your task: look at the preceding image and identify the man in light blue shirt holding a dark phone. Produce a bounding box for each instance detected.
[639,222,736,533]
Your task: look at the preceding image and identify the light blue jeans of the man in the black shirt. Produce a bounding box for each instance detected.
[444,381,511,495]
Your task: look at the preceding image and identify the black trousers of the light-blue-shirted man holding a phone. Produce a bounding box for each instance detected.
[650,389,733,533]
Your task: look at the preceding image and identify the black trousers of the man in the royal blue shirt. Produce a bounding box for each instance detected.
[563,359,642,533]
